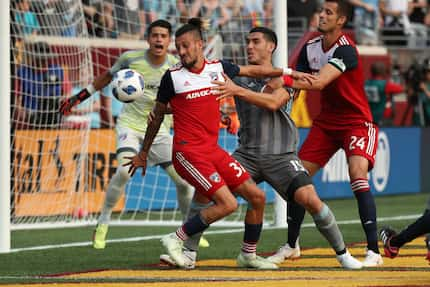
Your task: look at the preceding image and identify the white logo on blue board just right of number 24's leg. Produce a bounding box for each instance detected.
[371,131,390,192]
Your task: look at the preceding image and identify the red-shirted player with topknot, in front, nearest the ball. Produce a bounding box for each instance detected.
[123,19,306,269]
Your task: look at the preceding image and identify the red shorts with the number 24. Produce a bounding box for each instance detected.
[299,122,378,170]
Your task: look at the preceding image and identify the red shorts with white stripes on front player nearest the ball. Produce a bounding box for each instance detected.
[173,147,250,198]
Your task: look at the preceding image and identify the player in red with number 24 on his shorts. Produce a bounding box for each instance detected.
[270,0,383,267]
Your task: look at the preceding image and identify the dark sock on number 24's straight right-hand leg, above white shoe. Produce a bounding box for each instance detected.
[354,191,379,253]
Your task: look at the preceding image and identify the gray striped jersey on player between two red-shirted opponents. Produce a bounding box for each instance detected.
[234,77,298,155]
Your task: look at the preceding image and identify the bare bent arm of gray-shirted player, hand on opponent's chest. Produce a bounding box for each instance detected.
[212,74,290,111]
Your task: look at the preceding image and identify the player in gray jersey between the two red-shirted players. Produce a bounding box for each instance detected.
[160,27,362,269]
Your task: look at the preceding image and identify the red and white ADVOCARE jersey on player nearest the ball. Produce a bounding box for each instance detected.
[157,60,240,151]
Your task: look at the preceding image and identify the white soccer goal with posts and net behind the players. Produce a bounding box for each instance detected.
[0,0,288,253]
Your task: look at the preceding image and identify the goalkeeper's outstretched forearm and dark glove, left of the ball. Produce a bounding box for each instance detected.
[60,71,112,115]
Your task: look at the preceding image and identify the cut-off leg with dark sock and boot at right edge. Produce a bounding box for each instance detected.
[379,198,430,263]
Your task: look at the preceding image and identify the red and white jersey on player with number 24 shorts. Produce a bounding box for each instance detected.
[296,34,373,129]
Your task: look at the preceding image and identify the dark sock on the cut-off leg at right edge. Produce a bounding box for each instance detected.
[390,211,430,248]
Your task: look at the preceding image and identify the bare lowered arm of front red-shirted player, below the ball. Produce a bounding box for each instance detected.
[123,101,167,176]
